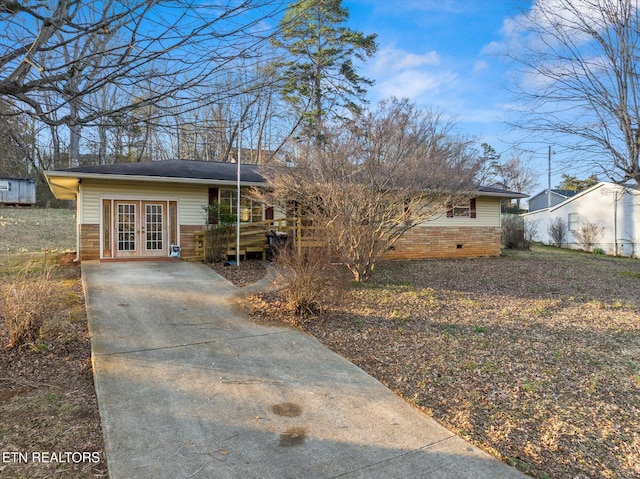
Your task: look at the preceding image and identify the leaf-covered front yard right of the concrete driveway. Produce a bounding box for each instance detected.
[248,248,640,478]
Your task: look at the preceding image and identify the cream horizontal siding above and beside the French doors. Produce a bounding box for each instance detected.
[79,180,209,225]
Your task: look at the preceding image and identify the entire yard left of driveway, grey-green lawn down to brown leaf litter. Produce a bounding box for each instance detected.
[0,208,107,479]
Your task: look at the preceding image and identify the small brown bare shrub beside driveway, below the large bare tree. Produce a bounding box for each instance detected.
[274,244,341,315]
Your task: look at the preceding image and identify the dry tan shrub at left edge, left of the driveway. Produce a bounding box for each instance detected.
[0,262,59,348]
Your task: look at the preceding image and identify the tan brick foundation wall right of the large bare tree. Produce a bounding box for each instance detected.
[384,226,500,260]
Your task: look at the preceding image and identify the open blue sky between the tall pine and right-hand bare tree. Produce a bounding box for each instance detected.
[343,0,561,193]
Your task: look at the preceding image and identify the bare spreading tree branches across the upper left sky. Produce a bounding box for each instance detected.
[0,0,284,162]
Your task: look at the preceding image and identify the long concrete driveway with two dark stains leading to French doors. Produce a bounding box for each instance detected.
[82,261,525,479]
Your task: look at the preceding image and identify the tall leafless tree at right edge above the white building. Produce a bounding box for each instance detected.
[509,0,640,183]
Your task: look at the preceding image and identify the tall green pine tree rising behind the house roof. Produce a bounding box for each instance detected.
[273,0,377,140]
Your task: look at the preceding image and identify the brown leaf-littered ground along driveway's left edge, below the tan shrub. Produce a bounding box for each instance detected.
[0,255,107,479]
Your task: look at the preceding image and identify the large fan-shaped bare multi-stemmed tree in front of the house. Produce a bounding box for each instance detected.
[265,99,479,281]
